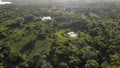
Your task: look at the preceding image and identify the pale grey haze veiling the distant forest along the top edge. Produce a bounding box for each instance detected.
[0,0,120,8]
